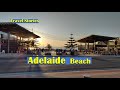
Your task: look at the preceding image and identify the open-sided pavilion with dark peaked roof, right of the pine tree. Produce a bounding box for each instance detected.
[78,35,120,54]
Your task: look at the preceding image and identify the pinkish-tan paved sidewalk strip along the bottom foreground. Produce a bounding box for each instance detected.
[0,69,120,78]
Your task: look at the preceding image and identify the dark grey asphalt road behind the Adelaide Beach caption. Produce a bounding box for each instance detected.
[0,56,120,77]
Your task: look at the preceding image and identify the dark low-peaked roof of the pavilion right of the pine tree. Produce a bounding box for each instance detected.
[78,35,117,43]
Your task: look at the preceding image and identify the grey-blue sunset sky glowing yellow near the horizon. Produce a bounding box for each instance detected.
[0,12,120,47]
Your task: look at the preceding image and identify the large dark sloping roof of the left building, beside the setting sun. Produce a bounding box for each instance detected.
[0,22,40,38]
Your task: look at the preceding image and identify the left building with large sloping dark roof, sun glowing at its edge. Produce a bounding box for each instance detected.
[0,22,40,53]
